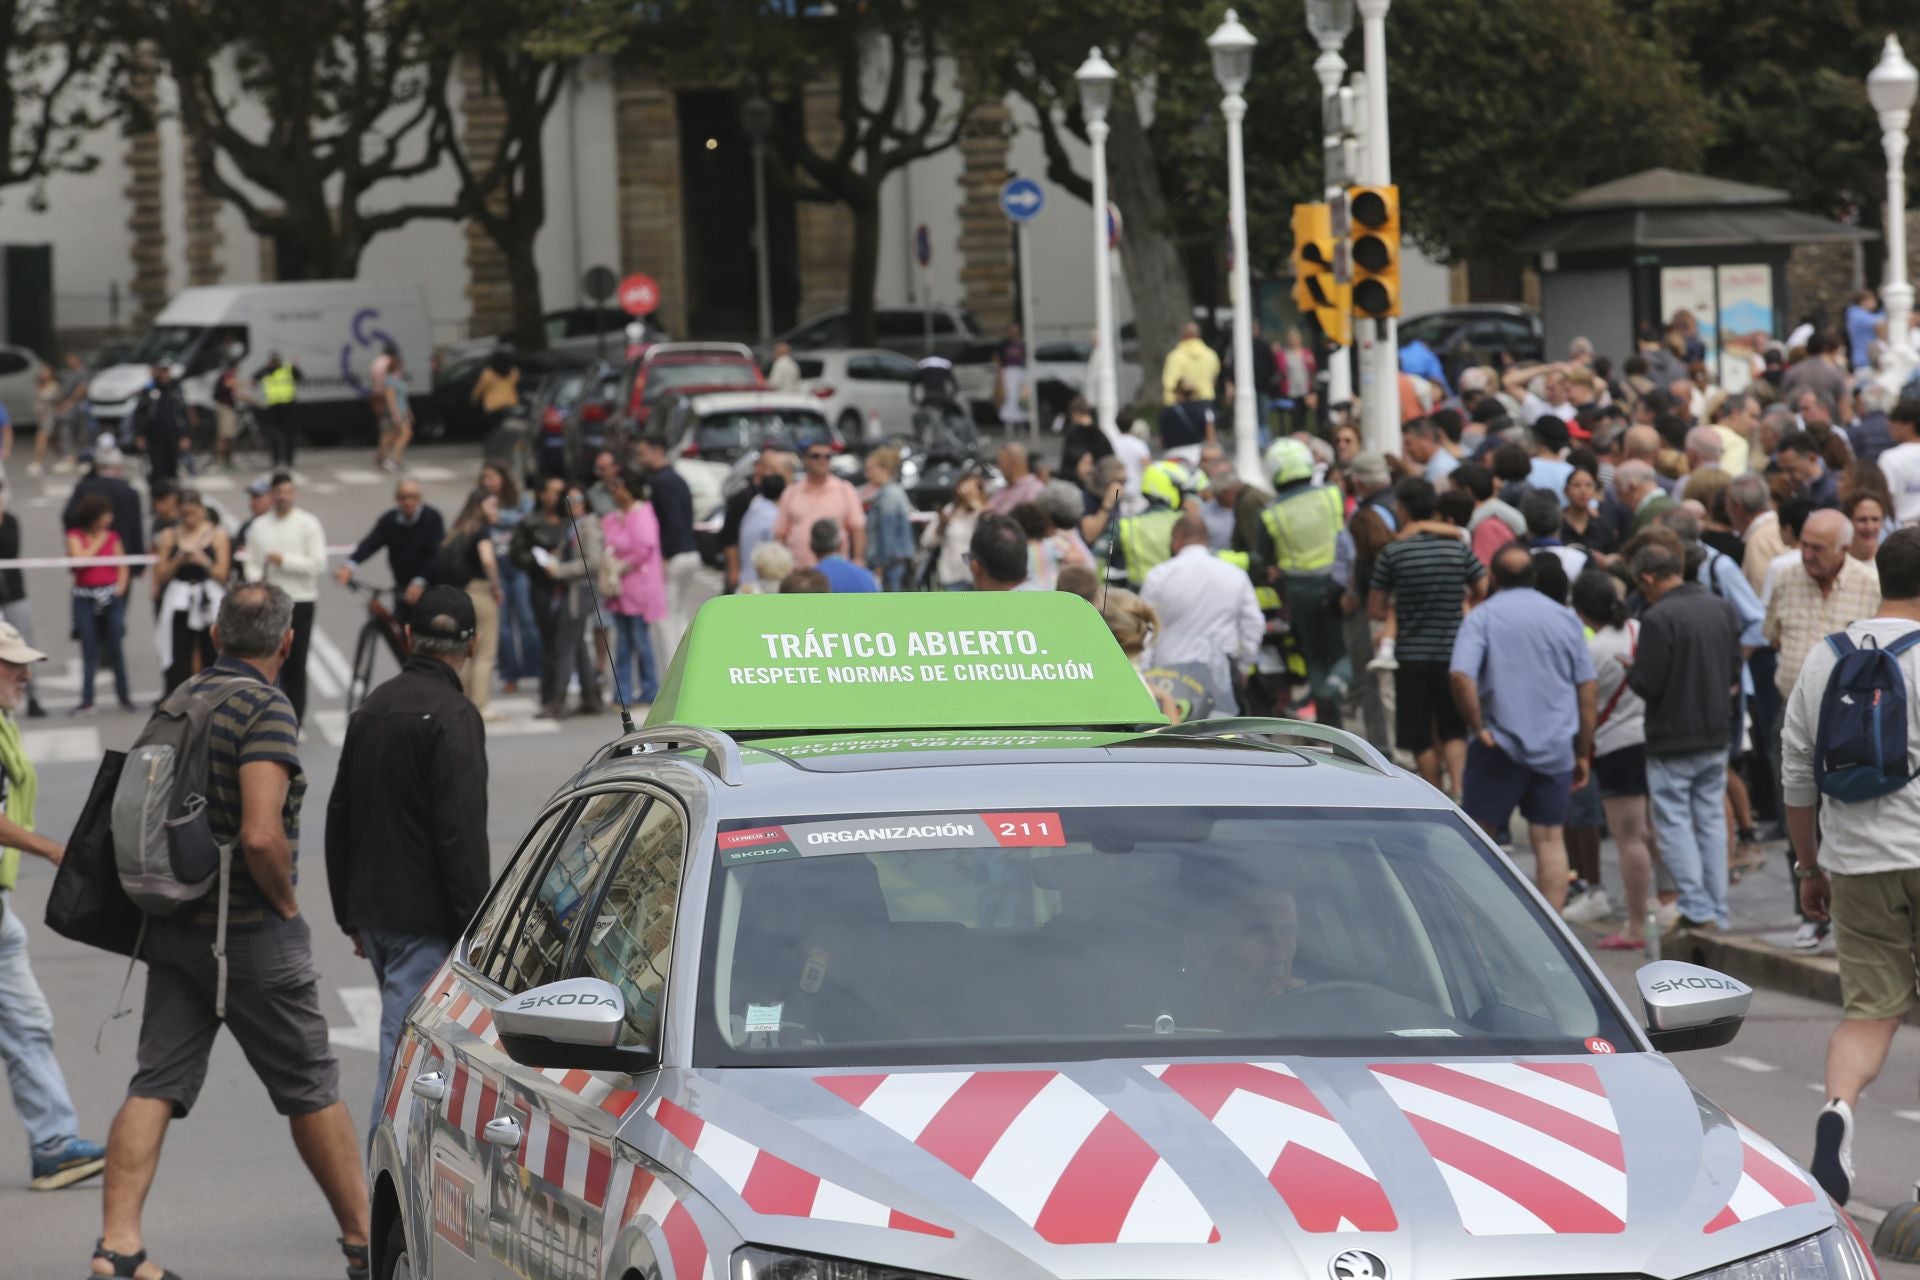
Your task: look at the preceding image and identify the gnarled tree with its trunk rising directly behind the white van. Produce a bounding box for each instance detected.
[102,0,461,280]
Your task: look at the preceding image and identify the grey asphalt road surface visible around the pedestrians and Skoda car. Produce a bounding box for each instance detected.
[0,449,1920,1280]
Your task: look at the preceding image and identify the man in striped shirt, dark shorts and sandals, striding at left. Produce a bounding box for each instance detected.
[92,583,369,1280]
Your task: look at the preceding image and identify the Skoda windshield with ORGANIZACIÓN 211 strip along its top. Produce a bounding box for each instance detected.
[695,808,1632,1067]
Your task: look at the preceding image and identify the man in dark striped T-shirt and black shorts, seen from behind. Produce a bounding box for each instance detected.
[1369,476,1486,787]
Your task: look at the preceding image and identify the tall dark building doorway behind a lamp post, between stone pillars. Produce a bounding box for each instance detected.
[678,88,801,342]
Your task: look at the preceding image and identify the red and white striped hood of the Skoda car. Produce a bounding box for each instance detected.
[637,1054,1834,1280]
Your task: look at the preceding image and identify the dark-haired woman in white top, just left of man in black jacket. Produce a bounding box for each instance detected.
[1572,570,1653,952]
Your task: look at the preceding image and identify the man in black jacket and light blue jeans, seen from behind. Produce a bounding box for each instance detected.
[1626,545,1743,929]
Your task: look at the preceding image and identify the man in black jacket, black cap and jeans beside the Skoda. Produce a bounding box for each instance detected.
[326,587,492,1132]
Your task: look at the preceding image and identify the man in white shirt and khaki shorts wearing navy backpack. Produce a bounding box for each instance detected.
[1780,528,1920,1203]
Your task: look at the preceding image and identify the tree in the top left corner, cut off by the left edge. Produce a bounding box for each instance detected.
[0,0,111,200]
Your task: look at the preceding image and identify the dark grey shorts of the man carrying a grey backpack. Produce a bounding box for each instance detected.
[127,913,340,1119]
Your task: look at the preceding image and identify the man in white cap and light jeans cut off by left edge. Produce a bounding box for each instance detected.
[0,622,108,1192]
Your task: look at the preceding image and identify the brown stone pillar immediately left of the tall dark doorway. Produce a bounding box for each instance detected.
[614,61,687,338]
